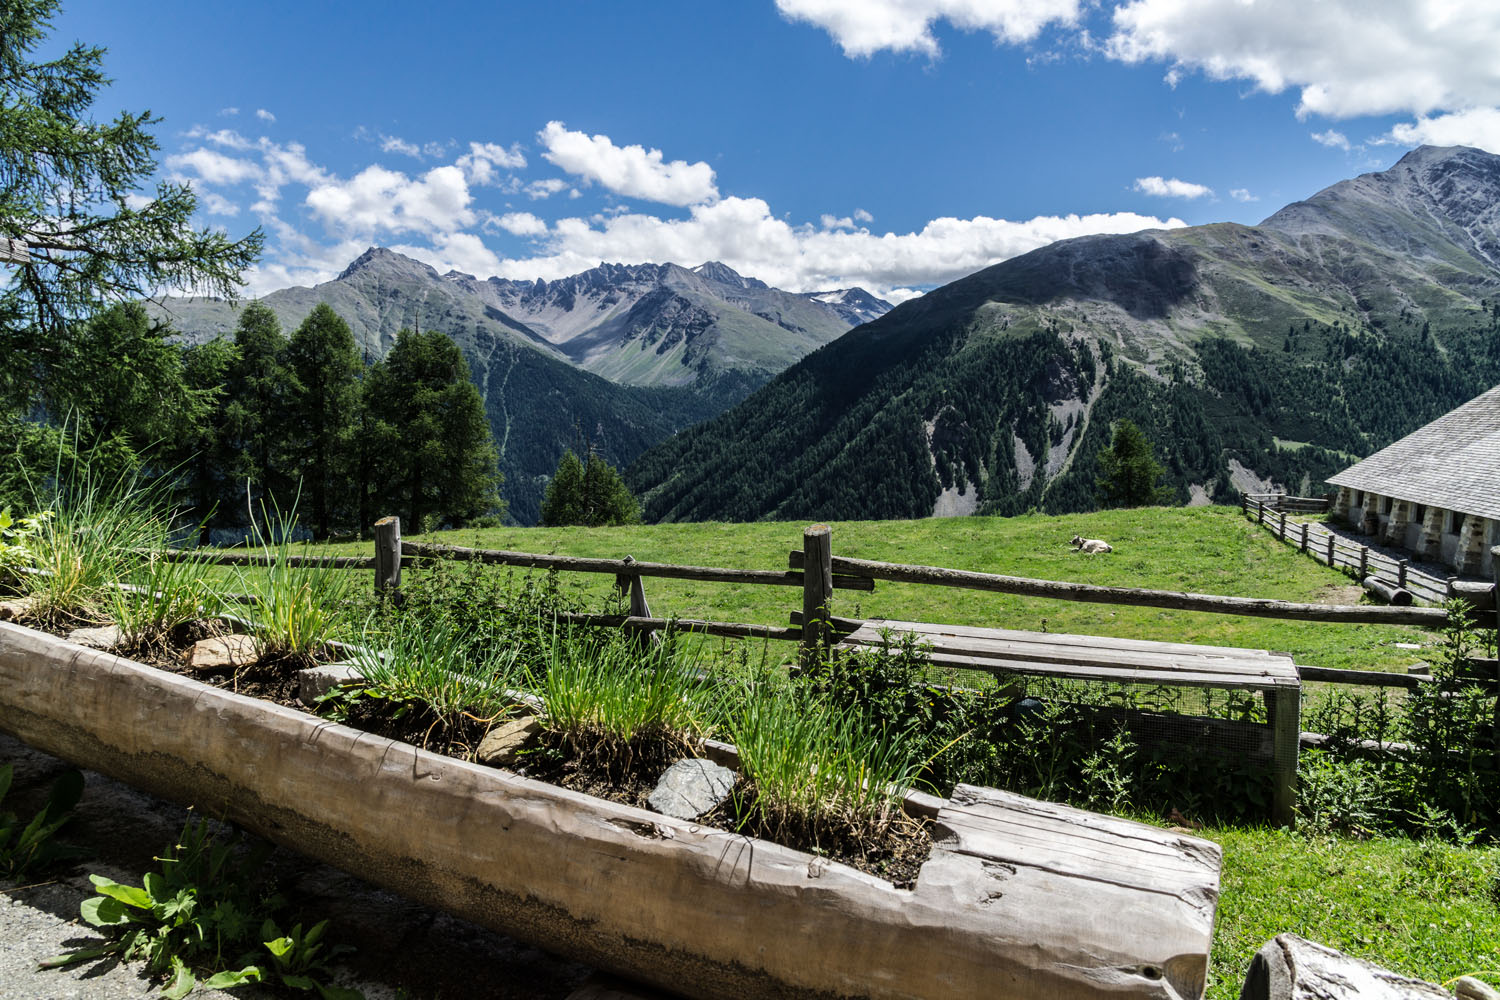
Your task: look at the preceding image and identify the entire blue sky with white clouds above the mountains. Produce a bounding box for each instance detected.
[51,0,1500,298]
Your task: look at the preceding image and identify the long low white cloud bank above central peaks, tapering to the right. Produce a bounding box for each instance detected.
[480,196,1184,297]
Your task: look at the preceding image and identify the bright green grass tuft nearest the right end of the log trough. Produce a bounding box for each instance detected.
[729,673,920,846]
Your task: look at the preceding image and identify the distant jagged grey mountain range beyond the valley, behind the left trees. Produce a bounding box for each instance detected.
[155,247,891,523]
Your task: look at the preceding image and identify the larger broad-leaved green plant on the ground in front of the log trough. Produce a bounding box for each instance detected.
[42,820,360,1000]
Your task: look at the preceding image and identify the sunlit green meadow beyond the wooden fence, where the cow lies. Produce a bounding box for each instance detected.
[339,507,1434,670]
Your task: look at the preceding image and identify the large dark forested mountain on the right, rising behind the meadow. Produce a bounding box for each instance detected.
[627,147,1500,524]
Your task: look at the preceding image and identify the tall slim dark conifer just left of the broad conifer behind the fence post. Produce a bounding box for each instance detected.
[287,303,363,538]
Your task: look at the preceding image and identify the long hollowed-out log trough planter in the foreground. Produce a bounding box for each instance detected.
[0,622,1220,1000]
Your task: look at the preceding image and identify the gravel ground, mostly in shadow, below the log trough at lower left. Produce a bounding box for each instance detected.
[0,735,597,1000]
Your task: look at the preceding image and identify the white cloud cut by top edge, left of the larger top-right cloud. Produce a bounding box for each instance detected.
[776,0,1080,57]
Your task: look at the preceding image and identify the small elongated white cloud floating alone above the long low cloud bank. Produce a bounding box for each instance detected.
[537,121,719,205]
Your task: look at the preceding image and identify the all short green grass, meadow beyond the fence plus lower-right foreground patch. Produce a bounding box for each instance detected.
[270,507,1500,1000]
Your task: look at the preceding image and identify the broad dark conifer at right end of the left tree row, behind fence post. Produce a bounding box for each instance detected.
[365,330,503,532]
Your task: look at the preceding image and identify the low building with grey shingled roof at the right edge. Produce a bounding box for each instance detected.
[1329,385,1500,576]
